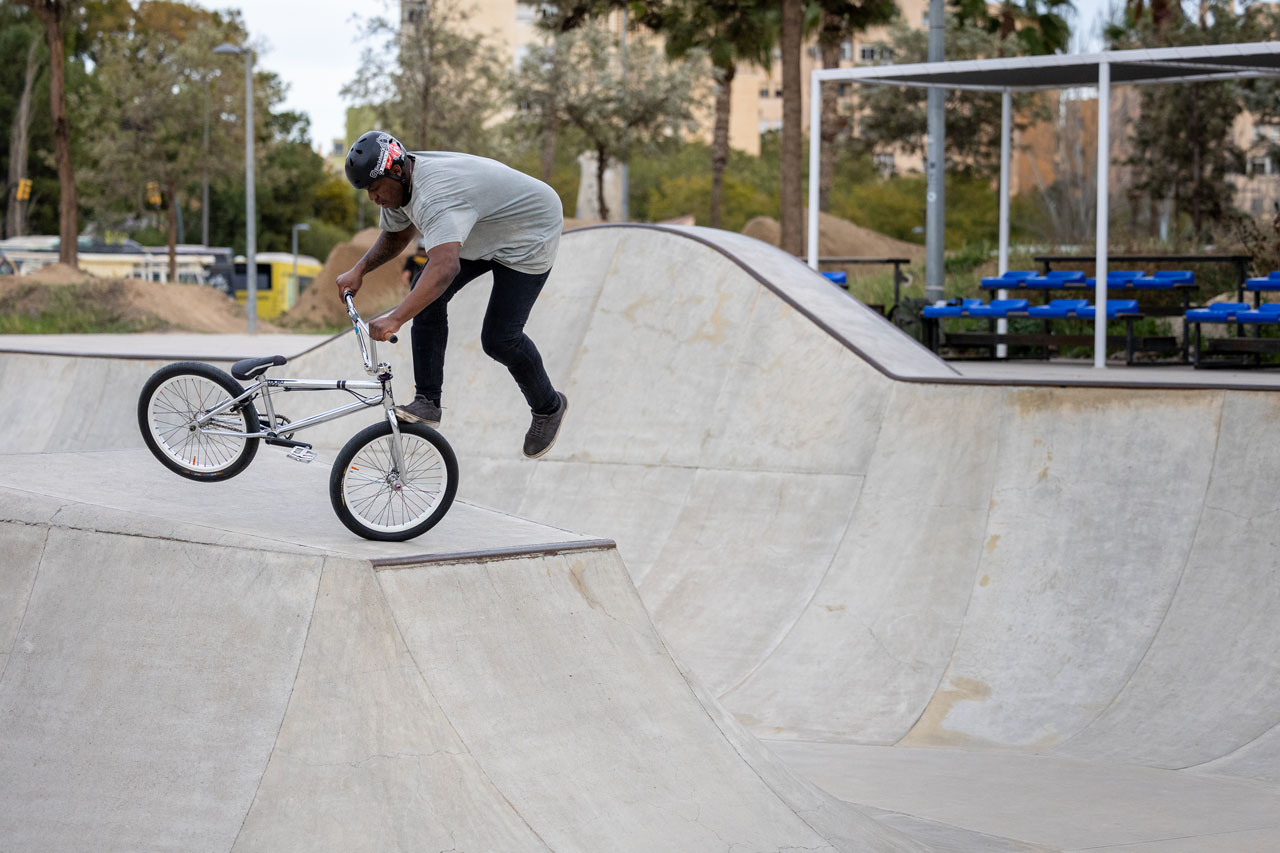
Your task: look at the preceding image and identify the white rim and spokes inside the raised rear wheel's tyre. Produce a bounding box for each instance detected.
[147,374,247,474]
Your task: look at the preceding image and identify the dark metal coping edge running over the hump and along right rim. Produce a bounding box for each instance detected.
[564,223,1277,393]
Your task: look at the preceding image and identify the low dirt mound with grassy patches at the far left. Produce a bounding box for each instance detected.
[0,270,282,333]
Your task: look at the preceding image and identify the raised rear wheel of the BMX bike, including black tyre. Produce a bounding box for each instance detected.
[138,361,260,483]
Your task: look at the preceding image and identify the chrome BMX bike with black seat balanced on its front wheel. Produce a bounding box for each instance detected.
[138,291,458,542]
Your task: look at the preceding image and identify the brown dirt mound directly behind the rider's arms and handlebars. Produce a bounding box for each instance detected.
[280,228,415,329]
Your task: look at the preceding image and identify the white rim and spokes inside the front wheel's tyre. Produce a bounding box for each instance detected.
[342,432,449,533]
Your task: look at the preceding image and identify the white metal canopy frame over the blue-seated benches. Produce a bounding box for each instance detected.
[809,41,1280,368]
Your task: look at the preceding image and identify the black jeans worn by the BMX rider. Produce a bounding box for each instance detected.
[412,259,559,412]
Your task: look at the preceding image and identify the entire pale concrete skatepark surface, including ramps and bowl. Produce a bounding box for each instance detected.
[0,227,1280,850]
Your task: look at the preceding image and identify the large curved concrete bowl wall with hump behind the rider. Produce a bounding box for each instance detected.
[399,227,1280,779]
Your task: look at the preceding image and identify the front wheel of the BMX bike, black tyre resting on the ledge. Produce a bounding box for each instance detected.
[329,421,458,542]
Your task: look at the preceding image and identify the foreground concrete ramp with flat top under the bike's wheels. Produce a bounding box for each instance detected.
[0,451,919,850]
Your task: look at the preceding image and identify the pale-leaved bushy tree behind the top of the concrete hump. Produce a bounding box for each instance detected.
[515,20,701,219]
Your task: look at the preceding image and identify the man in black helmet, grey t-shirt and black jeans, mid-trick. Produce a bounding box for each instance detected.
[338,131,568,459]
